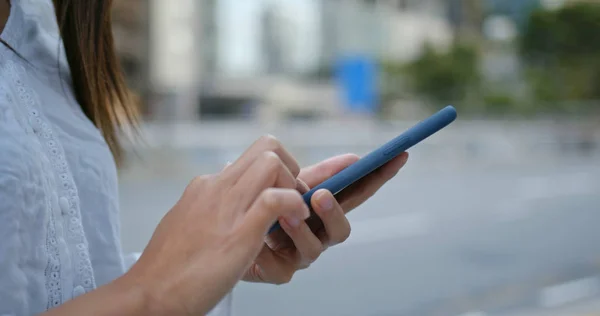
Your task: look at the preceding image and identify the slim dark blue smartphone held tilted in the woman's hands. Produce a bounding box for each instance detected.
[268,105,457,234]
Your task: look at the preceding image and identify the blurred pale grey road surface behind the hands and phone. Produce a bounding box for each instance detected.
[121,122,600,316]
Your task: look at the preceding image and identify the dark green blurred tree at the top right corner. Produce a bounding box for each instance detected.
[519,3,600,111]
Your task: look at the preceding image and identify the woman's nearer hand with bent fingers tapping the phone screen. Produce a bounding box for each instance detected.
[126,137,310,315]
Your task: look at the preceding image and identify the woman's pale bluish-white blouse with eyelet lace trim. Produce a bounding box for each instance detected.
[0,0,231,315]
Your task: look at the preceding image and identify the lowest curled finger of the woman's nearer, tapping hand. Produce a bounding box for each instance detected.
[244,188,310,240]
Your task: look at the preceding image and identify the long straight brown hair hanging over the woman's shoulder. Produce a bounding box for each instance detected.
[53,0,137,162]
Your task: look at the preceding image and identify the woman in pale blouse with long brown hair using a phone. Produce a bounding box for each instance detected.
[0,0,407,315]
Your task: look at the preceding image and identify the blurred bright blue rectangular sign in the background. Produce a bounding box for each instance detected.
[335,56,379,114]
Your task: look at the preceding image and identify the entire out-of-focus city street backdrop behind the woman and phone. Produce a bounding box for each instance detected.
[113,0,600,316]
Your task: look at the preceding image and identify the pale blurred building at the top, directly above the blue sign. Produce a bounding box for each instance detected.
[320,0,452,64]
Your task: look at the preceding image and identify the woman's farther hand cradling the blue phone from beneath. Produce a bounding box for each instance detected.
[243,153,408,284]
